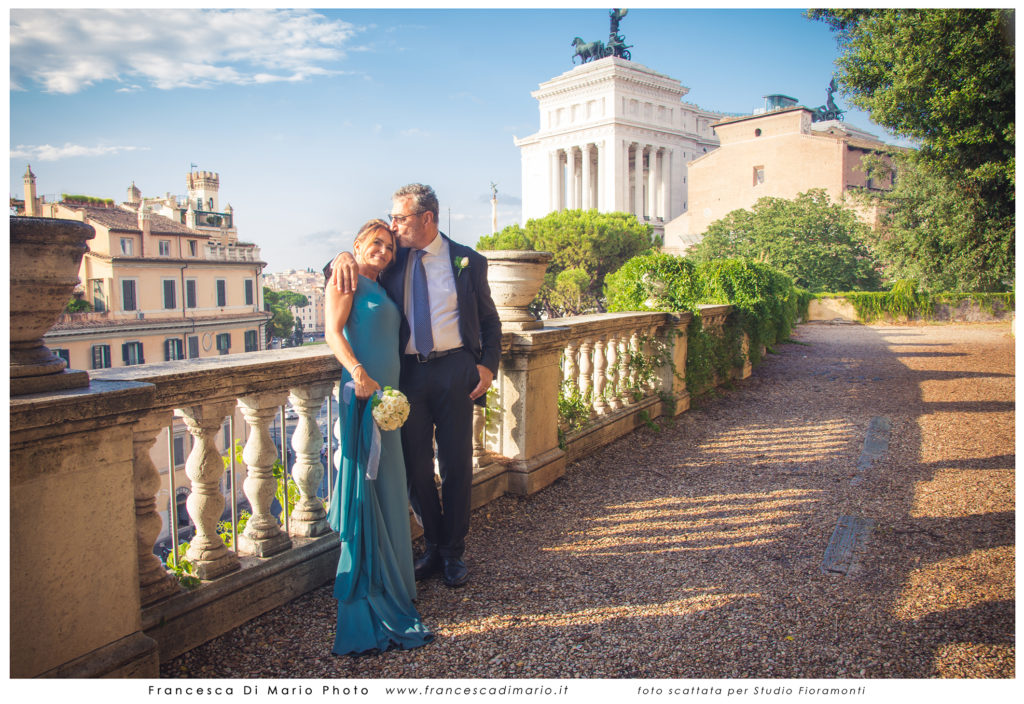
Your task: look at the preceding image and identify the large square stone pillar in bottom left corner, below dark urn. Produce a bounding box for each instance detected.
[7,380,160,678]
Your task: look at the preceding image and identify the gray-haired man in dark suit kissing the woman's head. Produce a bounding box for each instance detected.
[334,183,502,586]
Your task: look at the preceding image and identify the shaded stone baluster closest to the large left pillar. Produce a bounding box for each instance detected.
[132,410,180,606]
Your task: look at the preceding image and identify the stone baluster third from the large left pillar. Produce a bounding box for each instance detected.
[239,391,292,558]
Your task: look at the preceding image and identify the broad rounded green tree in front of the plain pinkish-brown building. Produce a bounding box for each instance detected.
[690,188,880,292]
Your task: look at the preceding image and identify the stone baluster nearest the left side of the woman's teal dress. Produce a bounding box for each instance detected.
[288,382,334,538]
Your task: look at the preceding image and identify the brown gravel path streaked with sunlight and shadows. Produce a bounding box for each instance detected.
[162,324,1015,678]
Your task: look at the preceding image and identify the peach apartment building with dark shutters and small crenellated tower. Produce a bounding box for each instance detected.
[25,169,269,369]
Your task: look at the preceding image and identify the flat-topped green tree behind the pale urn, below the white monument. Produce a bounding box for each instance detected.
[476,210,654,317]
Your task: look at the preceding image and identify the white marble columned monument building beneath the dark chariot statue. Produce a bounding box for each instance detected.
[515,56,723,234]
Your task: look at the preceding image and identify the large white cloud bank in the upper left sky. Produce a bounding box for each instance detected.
[10,9,357,93]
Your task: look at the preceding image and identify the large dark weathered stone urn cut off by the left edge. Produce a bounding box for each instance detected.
[10,217,96,396]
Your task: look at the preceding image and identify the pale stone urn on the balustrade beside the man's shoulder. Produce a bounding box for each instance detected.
[480,250,555,331]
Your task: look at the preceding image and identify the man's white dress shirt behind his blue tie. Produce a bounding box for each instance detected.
[406,233,462,354]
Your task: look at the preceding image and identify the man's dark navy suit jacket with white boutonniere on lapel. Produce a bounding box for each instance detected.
[381,233,502,403]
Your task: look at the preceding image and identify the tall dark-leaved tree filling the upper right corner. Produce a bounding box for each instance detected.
[809,8,1016,289]
